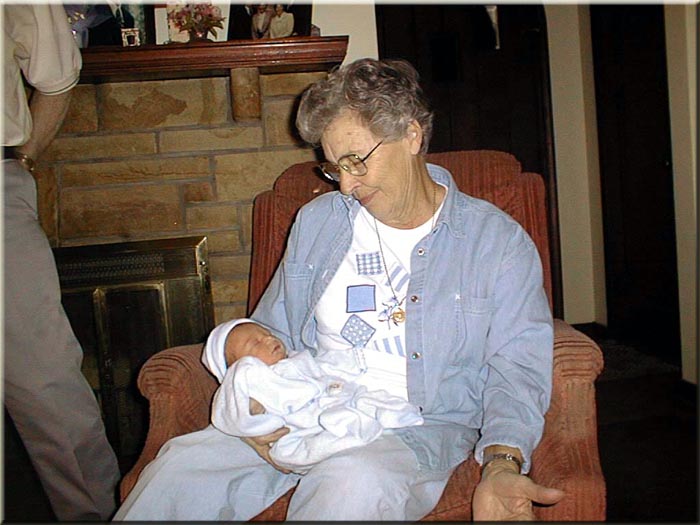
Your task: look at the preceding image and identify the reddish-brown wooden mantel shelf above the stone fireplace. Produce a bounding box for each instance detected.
[81,36,348,83]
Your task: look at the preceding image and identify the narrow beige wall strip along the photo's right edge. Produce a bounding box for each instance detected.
[664,5,698,384]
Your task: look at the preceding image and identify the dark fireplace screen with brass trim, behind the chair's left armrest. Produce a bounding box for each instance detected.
[54,237,213,472]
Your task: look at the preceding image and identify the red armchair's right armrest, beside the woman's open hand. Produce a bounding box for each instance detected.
[530,319,605,521]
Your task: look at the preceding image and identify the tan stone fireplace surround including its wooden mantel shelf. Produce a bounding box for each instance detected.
[37,37,347,323]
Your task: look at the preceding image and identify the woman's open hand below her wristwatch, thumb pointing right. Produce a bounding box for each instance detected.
[472,460,566,521]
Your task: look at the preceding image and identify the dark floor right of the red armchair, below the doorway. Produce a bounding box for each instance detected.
[591,328,698,523]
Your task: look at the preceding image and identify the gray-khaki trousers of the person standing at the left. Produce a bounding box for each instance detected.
[2,160,120,521]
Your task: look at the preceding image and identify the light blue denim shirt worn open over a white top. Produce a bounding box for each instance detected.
[252,164,553,473]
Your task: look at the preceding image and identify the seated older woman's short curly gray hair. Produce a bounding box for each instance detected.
[296,58,433,153]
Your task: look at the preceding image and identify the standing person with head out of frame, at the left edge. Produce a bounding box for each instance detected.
[2,4,119,521]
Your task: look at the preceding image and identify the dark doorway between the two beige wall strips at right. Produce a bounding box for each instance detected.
[590,5,680,364]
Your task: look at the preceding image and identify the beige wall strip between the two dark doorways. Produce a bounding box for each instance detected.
[545,5,607,325]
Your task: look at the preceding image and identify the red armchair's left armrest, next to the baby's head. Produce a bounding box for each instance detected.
[119,344,218,501]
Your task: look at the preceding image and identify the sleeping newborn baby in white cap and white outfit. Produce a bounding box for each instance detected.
[202,319,423,474]
